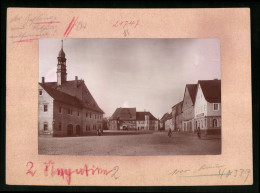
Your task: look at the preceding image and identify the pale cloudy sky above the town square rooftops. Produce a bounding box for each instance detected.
[39,38,221,118]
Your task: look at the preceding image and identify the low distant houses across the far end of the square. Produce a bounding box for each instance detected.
[108,108,159,131]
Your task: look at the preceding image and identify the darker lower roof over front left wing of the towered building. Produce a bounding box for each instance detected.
[40,83,82,107]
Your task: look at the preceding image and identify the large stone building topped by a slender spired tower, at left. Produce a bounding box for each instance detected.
[38,40,104,136]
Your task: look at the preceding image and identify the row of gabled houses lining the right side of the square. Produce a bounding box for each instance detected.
[160,79,221,134]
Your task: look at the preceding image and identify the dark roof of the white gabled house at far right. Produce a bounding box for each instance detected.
[198,79,221,103]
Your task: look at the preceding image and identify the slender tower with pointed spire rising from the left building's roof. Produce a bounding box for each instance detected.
[57,40,67,86]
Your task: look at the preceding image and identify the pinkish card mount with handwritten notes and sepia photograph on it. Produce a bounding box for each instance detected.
[6,8,253,186]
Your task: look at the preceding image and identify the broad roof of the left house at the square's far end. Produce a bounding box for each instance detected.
[110,108,136,120]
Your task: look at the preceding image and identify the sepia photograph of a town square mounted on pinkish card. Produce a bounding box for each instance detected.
[38,38,222,156]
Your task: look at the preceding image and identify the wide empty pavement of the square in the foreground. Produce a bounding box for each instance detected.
[39,131,221,156]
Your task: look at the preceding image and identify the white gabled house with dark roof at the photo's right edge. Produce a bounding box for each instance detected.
[194,79,221,134]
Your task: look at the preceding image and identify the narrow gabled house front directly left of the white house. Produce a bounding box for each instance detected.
[182,84,197,132]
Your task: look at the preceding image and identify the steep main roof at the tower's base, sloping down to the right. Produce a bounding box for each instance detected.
[41,80,104,113]
